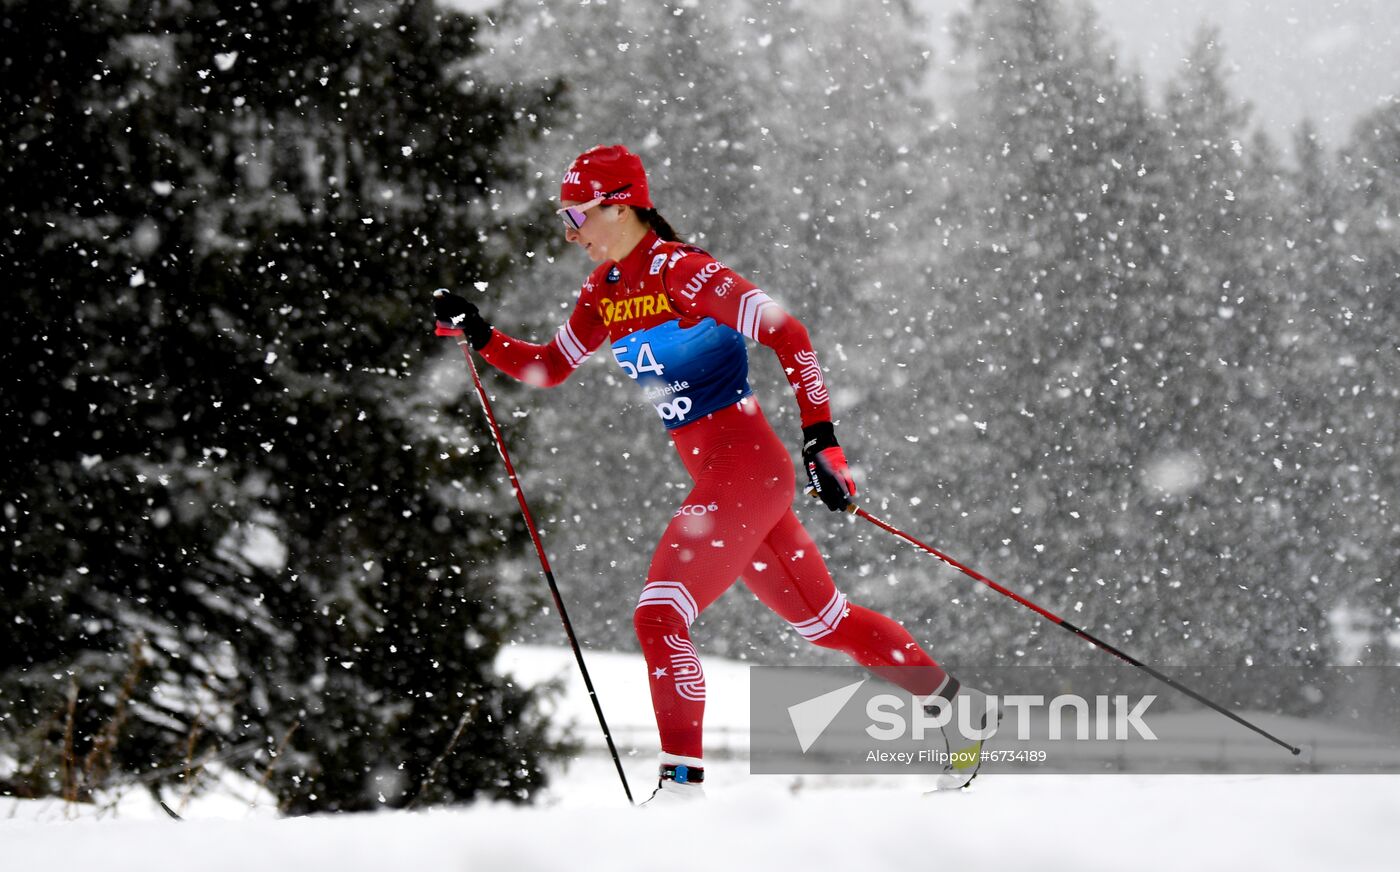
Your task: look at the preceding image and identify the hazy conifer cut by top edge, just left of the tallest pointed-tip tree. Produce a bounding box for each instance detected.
[942,0,1176,666]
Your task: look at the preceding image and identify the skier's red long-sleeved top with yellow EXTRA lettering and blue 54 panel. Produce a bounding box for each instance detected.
[480,231,832,430]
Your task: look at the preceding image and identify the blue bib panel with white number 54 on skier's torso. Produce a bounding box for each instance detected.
[612,318,753,430]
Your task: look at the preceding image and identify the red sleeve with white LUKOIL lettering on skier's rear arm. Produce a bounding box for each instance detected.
[665,245,832,427]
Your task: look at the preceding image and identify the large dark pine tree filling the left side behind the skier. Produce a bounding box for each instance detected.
[0,0,568,812]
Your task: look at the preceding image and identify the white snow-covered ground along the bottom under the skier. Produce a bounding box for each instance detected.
[0,648,1400,872]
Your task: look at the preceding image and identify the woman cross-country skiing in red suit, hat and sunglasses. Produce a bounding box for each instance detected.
[434,146,990,799]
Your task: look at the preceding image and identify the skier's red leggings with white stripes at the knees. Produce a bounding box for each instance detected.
[634,398,951,757]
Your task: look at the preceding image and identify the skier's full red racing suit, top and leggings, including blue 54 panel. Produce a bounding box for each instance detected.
[482,232,949,759]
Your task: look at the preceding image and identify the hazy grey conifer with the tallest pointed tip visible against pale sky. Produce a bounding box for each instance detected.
[1154,23,1329,665]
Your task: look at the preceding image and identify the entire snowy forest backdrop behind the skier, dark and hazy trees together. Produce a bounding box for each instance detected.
[0,0,1400,812]
